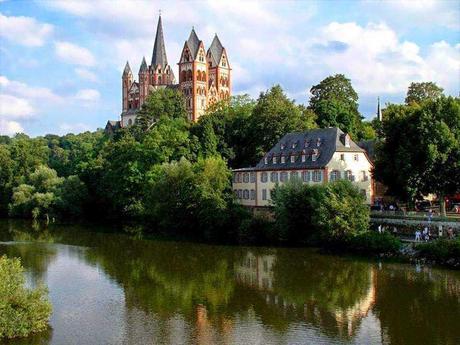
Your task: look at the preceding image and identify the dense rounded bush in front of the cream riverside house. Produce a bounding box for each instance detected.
[273,180,369,243]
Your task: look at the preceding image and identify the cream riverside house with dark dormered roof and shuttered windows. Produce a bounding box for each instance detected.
[232,128,374,207]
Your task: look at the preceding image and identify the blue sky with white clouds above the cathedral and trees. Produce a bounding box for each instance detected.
[0,0,460,136]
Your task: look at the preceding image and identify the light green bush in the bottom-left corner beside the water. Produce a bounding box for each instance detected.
[0,256,51,339]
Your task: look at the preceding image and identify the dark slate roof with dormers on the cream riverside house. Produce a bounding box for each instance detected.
[256,127,365,170]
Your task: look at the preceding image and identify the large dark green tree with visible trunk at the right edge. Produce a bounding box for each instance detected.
[375,97,460,215]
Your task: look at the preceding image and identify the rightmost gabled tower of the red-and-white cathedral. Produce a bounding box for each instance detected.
[206,34,231,105]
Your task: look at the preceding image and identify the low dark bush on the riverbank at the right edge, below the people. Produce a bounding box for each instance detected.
[417,238,460,263]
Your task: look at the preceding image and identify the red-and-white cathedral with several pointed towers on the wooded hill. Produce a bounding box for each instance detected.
[106,15,231,132]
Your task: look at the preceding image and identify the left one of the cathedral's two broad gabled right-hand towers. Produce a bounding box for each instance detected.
[178,29,208,121]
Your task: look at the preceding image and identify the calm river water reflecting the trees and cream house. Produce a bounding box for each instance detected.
[0,221,460,345]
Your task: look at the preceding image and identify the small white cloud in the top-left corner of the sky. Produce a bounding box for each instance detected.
[0,13,53,47]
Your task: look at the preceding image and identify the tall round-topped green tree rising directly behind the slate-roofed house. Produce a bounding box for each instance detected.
[309,74,362,139]
